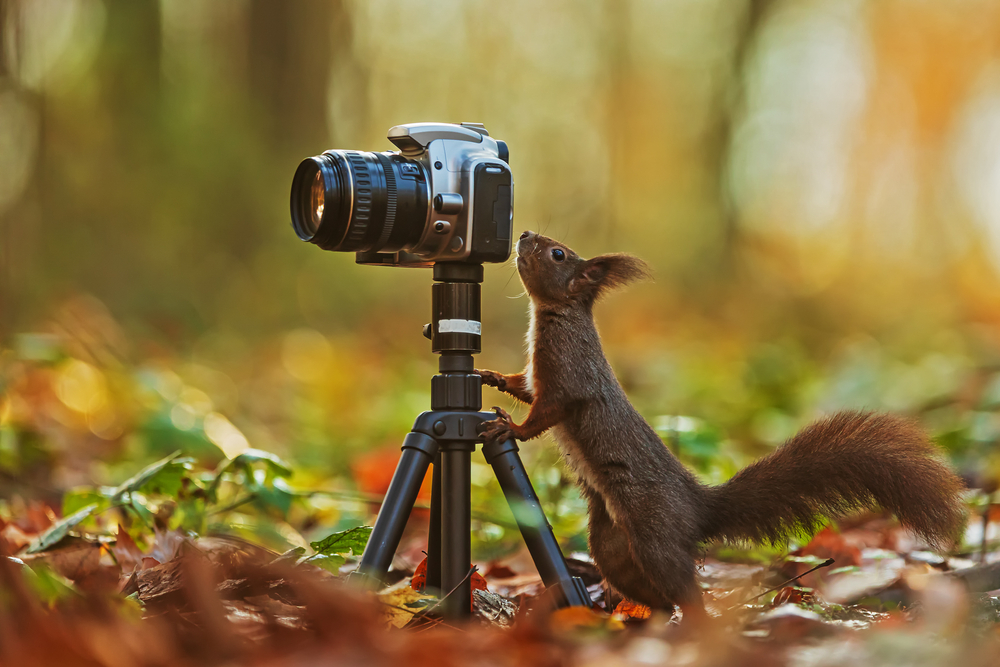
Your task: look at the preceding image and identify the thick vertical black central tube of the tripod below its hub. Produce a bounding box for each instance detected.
[441,442,475,618]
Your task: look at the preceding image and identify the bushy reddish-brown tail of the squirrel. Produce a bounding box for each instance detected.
[702,412,963,547]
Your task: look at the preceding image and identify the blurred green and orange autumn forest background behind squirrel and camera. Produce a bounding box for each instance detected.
[0,0,1000,550]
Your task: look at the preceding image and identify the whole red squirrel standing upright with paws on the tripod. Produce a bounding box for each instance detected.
[476,232,964,614]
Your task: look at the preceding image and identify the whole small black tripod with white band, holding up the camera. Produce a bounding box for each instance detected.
[359,263,590,618]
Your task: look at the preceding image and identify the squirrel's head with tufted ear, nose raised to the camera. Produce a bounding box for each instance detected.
[517,232,650,306]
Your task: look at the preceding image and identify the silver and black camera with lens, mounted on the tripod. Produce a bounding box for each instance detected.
[291,123,514,266]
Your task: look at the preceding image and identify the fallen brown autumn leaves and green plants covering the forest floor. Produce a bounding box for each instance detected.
[0,451,1000,667]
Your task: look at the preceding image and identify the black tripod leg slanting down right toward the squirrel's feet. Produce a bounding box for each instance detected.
[483,439,590,607]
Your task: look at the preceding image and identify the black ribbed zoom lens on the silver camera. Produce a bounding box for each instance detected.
[291,151,429,252]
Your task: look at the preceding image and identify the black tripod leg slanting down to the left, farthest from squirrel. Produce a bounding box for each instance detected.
[358,432,438,582]
